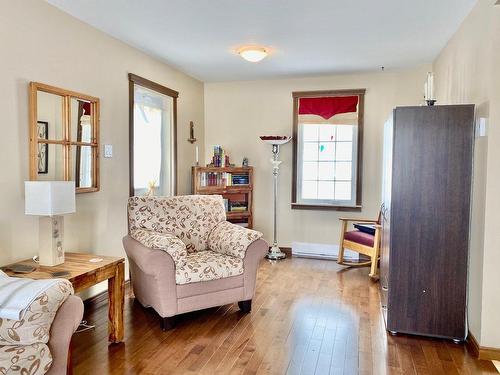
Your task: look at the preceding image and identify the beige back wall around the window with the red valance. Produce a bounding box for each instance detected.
[205,66,430,246]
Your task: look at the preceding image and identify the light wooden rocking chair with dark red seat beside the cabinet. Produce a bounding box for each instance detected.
[337,213,382,278]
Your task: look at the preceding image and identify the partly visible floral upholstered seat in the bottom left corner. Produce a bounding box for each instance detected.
[0,282,83,375]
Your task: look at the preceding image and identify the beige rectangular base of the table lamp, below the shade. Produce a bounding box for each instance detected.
[38,216,64,266]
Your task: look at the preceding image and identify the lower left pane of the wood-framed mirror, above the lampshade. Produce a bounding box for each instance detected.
[37,143,64,181]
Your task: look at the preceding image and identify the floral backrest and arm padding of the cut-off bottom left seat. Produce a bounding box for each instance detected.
[0,279,73,345]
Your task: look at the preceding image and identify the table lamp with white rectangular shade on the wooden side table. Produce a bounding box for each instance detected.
[24,181,75,266]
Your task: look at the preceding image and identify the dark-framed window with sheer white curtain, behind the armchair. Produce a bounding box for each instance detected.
[129,74,178,196]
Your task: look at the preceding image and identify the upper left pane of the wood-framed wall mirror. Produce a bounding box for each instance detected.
[37,91,64,141]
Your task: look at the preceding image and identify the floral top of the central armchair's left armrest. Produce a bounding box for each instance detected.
[130,229,187,268]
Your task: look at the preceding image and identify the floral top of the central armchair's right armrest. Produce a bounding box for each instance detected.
[208,221,262,259]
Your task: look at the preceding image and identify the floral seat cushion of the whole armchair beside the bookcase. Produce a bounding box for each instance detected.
[175,250,243,285]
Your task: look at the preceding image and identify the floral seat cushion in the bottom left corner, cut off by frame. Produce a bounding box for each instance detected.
[0,343,52,375]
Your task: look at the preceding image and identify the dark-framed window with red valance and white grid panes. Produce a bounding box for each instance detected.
[292,90,365,210]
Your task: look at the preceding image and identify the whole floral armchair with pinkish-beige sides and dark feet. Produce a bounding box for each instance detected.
[123,195,268,330]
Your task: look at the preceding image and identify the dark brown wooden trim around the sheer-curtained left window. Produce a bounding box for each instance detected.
[128,73,179,197]
